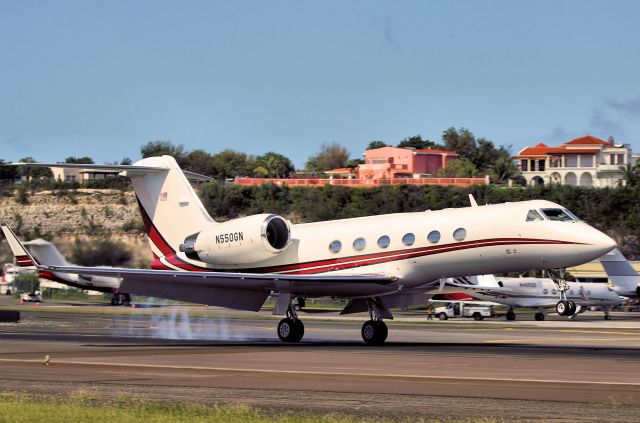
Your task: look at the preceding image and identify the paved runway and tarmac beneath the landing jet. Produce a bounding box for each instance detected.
[0,306,640,421]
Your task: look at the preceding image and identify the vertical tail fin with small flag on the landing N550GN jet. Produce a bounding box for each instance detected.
[126,156,215,256]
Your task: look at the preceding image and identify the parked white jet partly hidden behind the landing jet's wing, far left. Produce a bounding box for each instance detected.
[20,238,131,306]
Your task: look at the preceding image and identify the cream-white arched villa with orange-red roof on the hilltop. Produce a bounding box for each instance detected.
[514,135,633,187]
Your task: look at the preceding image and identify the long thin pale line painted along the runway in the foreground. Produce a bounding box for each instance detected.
[0,358,640,387]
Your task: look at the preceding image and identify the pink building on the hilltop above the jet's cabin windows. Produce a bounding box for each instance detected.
[358,147,458,179]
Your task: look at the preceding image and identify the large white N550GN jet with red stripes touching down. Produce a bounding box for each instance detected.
[2,156,615,344]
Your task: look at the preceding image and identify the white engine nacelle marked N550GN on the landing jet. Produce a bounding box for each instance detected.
[180,214,291,265]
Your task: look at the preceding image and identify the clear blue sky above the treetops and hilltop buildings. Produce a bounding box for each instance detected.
[0,0,640,166]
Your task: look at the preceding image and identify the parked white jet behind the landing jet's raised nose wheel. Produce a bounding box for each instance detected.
[448,275,626,320]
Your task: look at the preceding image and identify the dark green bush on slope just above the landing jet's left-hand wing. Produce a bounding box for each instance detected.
[70,238,132,267]
